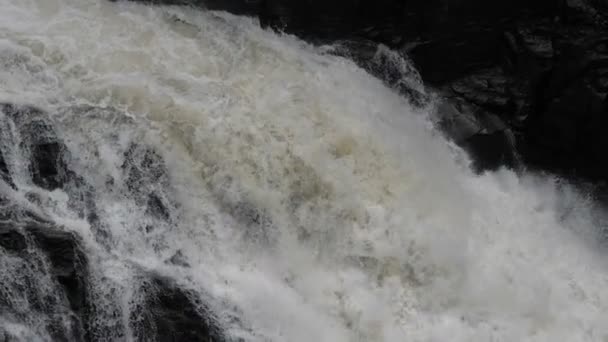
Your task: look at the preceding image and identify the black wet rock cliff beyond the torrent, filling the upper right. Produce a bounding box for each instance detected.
[117,0,608,182]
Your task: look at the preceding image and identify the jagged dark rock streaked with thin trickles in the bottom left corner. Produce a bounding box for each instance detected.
[0,215,88,342]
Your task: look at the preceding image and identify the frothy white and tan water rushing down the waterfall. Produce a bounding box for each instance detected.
[0,0,608,342]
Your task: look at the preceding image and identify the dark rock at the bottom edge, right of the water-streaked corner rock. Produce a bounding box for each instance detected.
[131,276,224,342]
